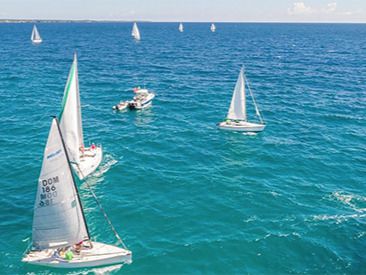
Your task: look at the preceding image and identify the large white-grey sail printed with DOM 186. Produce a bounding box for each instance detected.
[32,119,89,249]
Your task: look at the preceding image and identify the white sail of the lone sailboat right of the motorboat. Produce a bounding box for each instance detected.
[227,69,247,121]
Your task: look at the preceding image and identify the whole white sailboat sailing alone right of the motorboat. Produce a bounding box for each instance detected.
[218,68,266,132]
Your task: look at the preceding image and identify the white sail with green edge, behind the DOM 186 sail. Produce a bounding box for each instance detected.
[59,54,84,166]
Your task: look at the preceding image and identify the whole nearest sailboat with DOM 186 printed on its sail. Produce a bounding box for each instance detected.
[22,117,132,268]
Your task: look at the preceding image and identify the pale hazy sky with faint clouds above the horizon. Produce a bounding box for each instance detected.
[0,0,366,23]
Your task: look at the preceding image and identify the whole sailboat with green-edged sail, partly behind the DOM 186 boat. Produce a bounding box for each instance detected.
[59,53,103,180]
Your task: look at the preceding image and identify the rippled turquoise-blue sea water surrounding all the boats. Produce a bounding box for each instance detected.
[0,23,366,274]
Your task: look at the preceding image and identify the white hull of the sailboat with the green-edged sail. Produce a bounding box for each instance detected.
[72,146,103,180]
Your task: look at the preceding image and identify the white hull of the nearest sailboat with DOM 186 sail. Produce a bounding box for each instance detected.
[22,242,132,268]
